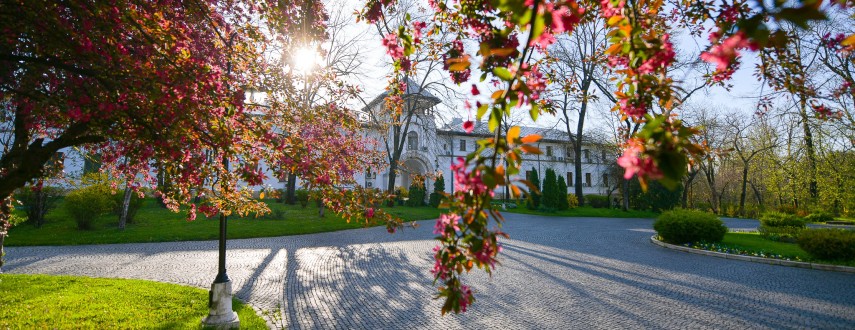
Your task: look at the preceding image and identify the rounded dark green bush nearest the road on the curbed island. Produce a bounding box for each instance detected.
[653,209,727,244]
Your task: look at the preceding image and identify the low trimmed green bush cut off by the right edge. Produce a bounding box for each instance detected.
[798,229,855,260]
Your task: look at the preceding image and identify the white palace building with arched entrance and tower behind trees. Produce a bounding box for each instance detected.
[31,82,616,198]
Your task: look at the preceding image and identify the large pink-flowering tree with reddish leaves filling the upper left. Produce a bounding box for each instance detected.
[0,0,396,270]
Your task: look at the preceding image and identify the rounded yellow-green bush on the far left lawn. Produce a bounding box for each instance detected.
[63,183,115,230]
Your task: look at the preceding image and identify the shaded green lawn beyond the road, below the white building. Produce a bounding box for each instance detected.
[5,199,440,246]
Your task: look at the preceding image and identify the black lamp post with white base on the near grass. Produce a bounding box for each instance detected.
[202,32,240,329]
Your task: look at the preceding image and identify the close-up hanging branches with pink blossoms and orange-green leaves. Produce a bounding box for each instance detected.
[361,0,855,313]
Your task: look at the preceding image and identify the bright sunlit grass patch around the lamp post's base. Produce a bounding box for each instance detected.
[0,274,267,329]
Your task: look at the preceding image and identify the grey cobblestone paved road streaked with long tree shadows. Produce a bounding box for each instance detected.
[4,214,855,329]
